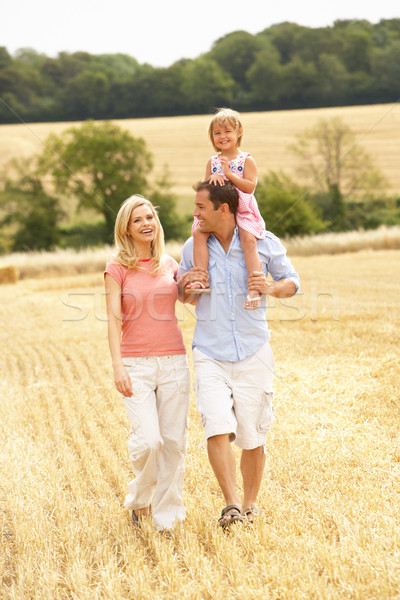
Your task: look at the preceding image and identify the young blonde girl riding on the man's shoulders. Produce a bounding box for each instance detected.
[192,108,266,310]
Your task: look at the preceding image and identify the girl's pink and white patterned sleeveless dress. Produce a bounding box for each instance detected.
[192,152,266,240]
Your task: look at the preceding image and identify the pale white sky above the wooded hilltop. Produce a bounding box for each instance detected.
[0,0,400,67]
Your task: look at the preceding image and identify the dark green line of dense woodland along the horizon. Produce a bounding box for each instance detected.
[0,19,400,123]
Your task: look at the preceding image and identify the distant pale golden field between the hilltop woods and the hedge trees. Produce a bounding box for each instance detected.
[0,103,400,212]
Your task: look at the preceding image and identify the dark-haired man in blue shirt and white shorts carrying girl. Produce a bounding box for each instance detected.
[179,182,299,528]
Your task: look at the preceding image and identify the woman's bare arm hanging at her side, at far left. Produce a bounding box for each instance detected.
[105,273,132,397]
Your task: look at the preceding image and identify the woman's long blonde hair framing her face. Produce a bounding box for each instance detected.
[114,194,164,275]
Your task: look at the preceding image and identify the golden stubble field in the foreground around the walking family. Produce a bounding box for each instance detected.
[0,250,400,600]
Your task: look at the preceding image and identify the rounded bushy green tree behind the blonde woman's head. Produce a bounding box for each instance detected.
[39,121,152,241]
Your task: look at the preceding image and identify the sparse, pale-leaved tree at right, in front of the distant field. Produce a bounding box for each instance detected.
[289,117,387,229]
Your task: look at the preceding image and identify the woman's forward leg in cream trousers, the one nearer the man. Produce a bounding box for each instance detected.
[152,354,190,529]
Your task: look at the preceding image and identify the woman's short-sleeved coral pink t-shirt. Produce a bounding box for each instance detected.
[104,255,186,356]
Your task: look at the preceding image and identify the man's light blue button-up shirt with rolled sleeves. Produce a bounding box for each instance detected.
[179,227,300,362]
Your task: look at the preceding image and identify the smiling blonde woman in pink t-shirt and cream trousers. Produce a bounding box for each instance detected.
[104,196,190,530]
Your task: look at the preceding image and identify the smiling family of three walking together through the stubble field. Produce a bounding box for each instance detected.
[105,109,299,533]
